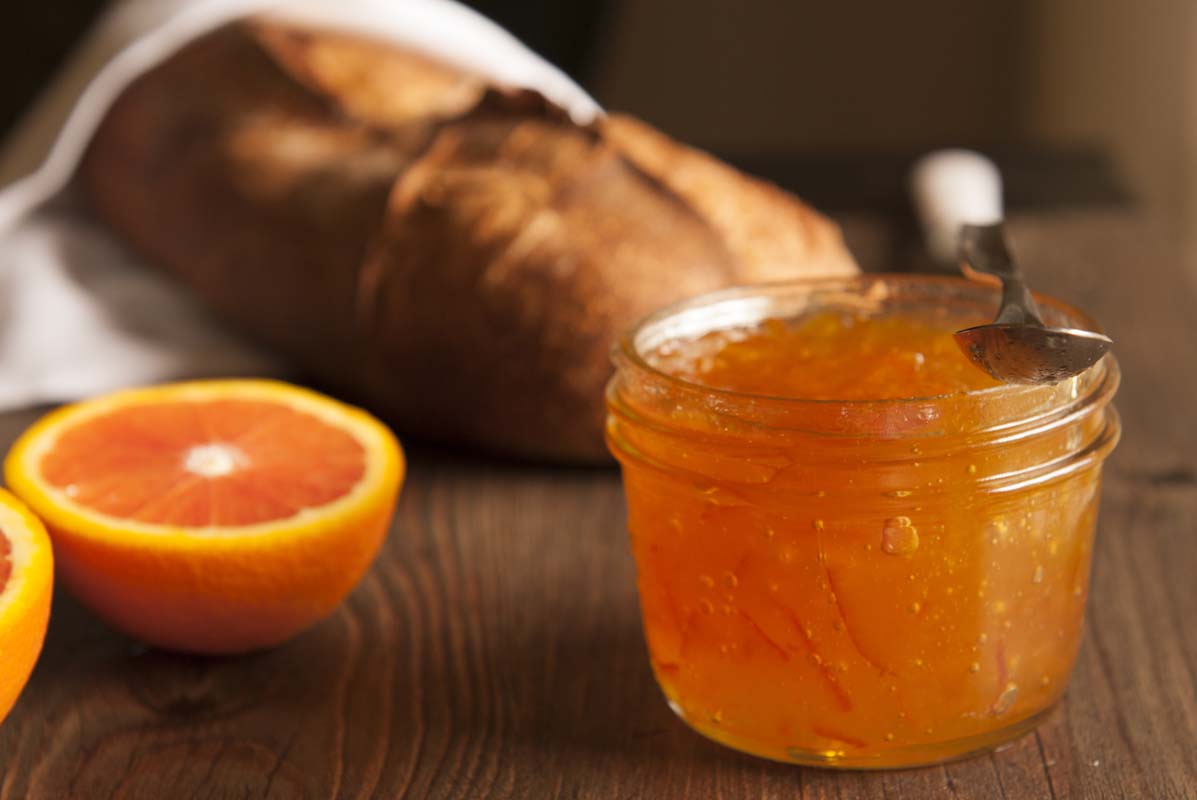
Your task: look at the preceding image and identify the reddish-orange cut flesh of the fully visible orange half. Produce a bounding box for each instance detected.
[41,400,365,527]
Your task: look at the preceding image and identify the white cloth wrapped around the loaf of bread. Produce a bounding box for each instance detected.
[0,0,601,411]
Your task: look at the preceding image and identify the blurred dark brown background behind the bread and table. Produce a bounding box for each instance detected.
[7,0,1197,227]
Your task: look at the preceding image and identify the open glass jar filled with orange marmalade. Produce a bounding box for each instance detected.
[608,275,1119,768]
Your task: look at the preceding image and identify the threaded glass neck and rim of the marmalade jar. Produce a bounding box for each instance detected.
[607,275,1119,491]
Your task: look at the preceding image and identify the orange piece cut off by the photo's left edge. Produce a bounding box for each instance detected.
[0,489,54,722]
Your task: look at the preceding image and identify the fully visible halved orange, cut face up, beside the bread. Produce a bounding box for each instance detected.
[5,380,403,653]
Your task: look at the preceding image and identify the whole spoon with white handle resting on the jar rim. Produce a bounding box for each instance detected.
[911,150,1112,383]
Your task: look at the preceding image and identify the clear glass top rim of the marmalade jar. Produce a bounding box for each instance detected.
[612,273,1117,408]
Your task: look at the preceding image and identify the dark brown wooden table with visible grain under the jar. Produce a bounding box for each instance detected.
[0,210,1197,800]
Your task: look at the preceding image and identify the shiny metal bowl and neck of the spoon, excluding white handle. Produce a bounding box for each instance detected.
[955,223,1113,383]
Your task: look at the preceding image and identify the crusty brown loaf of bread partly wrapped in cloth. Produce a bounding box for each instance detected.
[83,20,856,461]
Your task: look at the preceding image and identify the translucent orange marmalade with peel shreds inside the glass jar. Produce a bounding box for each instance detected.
[612,313,1098,766]
